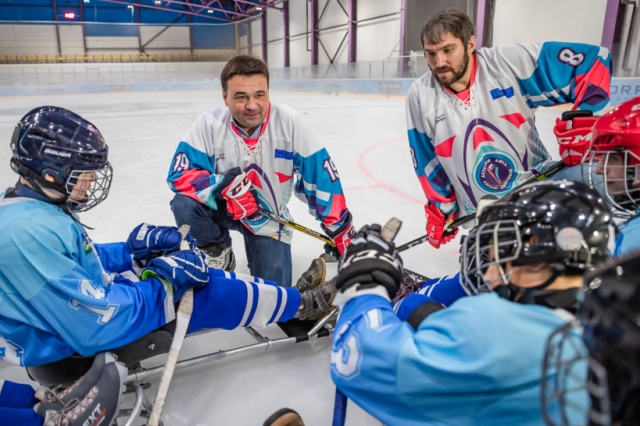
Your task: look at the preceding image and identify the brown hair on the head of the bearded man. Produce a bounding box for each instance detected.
[420,9,475,48]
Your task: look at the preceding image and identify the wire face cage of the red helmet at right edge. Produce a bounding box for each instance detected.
[589,147,640,216]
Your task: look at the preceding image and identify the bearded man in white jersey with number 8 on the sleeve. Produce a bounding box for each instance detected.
[406,10,611,248]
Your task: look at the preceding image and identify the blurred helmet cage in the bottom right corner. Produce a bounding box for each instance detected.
[540,320,611,426]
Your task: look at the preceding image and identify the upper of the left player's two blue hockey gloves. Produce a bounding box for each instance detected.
[127,223,196,268]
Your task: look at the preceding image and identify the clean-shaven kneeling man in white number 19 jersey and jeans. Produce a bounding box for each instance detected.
[167,56,355,287]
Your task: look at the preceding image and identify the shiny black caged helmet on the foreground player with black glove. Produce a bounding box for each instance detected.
[461,181,615,298]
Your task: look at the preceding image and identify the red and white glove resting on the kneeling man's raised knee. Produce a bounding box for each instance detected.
[213,167,258,220]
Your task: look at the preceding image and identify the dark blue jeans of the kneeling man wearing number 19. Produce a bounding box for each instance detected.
[171,194,291,287]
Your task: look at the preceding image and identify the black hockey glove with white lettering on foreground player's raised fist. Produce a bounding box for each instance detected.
[336,224,403,298]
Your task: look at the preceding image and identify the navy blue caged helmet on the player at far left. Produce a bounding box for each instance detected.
[11,106,112,212]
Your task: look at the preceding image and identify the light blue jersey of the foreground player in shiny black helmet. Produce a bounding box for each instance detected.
[331,293,587,426]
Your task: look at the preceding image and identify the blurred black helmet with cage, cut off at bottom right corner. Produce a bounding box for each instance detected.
[542,250,640,426]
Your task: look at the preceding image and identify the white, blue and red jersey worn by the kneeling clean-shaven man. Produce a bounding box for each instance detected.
[167,103,349,243]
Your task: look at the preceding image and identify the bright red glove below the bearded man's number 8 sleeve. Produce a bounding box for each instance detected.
[553,111,598,166]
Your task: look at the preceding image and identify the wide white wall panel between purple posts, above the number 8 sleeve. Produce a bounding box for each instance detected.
[493,0,607,46]
